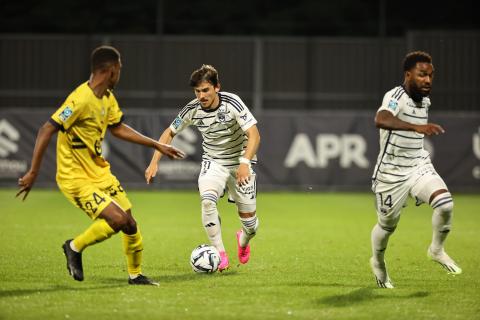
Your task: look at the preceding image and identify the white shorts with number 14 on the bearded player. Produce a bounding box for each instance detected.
[372,163,448,228]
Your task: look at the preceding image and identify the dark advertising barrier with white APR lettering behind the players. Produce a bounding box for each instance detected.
[0,109,480,191]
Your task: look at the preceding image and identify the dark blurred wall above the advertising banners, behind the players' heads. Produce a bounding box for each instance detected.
[0,31,480,112]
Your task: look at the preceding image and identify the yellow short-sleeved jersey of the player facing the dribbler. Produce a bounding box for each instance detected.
[50,82,123,182]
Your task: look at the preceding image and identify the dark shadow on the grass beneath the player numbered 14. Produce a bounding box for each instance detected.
[315,288,430,307]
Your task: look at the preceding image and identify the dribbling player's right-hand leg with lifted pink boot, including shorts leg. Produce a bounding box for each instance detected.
[227,169,259,264]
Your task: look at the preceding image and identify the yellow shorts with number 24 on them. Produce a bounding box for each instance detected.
[57,174,132,219]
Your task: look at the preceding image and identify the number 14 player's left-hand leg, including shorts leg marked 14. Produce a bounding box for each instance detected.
[370,184,408,288]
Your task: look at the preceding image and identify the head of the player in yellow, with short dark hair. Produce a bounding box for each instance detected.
[90,46,122,89]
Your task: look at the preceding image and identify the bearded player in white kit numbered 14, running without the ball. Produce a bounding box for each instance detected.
[370,51,462,288]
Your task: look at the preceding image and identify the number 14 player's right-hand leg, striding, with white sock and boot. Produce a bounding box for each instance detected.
[412,170,462,274]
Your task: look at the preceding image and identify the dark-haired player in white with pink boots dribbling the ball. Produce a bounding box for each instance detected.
[145,65,260,271]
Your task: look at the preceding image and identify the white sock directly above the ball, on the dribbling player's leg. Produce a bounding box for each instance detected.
[202,192,225,252]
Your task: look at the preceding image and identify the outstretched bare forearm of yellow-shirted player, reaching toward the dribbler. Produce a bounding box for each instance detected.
[109,123,185,159]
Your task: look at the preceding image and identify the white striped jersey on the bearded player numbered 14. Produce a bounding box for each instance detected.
[372,86,430,184]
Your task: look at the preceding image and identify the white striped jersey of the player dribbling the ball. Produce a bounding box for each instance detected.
[170,92,257,167]
